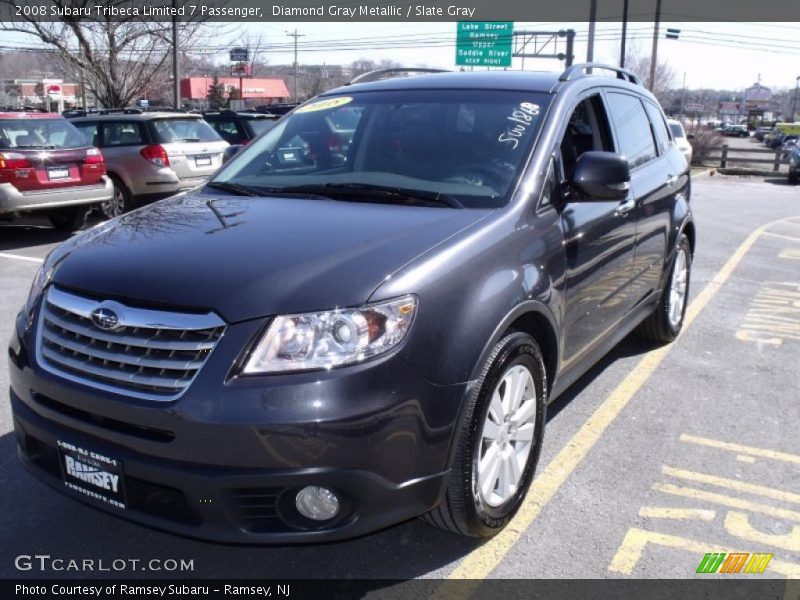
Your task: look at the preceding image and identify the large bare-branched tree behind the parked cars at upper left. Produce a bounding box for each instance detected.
[0,0,227,106]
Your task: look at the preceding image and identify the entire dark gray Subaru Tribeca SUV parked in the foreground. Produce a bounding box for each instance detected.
[10,66,695,543]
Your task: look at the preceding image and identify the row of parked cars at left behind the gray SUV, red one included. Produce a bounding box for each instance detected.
[0,104,295,231]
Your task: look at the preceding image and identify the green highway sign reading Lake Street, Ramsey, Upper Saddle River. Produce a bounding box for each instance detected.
[456,21,514,67]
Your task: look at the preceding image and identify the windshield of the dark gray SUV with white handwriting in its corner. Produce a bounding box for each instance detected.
[213,90,549,208]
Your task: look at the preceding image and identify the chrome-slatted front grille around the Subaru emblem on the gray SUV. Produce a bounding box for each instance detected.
[36,286,225,400]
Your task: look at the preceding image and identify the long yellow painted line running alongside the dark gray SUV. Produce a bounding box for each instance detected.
[432,214,800,584]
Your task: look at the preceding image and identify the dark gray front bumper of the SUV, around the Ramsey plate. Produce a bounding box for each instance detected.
[9,310,466,543]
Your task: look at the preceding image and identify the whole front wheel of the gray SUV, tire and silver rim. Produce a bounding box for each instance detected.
[422,332,548,538]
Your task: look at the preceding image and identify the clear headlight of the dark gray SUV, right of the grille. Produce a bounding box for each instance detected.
[242,296,417,375]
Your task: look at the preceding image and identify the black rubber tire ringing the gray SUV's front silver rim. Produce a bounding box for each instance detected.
[468,333,547,531]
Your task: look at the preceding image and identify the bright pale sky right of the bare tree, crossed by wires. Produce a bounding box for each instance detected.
[222,22,800,90]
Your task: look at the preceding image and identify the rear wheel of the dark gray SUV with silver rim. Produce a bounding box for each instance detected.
[638,234,692,344]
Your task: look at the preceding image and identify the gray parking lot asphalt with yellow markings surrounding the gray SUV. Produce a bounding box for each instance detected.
[0,176,800,579]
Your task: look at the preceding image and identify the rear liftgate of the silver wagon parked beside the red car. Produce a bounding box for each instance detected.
[150,116,229,179]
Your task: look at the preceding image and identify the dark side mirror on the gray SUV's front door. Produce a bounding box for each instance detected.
[570,151,631,201]
